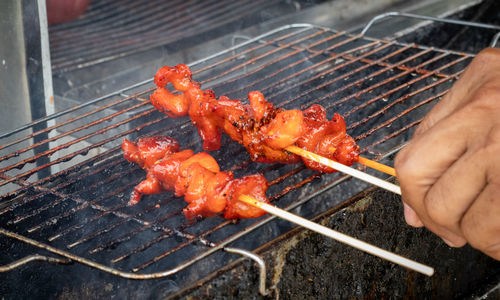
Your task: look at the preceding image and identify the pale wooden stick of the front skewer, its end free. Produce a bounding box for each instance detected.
[239,195,434,276]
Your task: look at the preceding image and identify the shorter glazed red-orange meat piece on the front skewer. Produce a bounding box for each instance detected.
[122,136,269,219]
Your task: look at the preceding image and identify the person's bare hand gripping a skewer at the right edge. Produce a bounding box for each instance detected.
[395,48,500,260]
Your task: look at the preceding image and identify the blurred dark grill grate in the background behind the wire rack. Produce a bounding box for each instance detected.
[49,0,311,72]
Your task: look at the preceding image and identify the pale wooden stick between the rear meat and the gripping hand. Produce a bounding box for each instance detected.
[285,146,401,195]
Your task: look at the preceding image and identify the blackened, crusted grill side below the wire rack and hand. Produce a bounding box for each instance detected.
[171,189,500,299]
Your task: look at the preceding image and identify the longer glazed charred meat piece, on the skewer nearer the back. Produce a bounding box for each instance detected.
[150,64,359,173]
